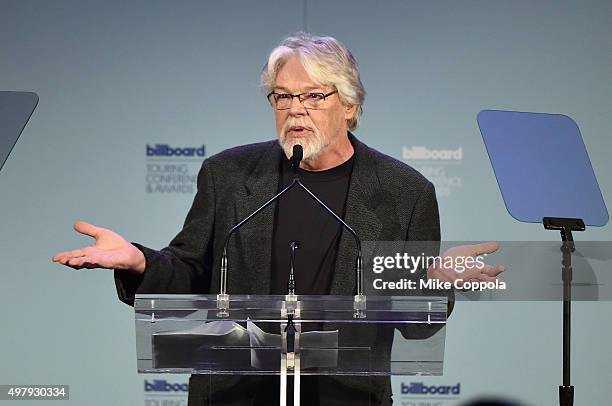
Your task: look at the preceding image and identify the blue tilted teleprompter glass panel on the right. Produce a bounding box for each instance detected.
[478,110,608,226]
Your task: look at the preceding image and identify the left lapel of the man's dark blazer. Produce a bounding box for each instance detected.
[234,142,282,295]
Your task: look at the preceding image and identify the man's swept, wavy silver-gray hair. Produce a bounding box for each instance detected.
[261,32,365,131]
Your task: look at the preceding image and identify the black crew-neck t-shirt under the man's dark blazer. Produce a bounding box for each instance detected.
[270,157,353,295]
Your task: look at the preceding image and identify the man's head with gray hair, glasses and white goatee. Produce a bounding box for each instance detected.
[261,33,365,169]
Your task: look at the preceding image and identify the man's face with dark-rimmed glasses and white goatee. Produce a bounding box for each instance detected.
[274,58,355,162]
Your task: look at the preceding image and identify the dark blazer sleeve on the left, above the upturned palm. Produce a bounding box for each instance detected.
[114,160,216,306]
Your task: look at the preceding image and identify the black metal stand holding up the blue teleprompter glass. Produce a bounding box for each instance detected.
[543,217,585,406]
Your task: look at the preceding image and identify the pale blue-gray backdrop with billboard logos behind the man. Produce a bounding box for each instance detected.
[0,0,612,406]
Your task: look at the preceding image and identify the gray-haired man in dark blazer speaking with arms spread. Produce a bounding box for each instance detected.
[53,33,501,405]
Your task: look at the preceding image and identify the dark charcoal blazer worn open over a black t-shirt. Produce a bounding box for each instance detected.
[115,133,440,405]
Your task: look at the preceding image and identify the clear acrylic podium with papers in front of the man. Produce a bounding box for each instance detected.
[134,295,448,405]
